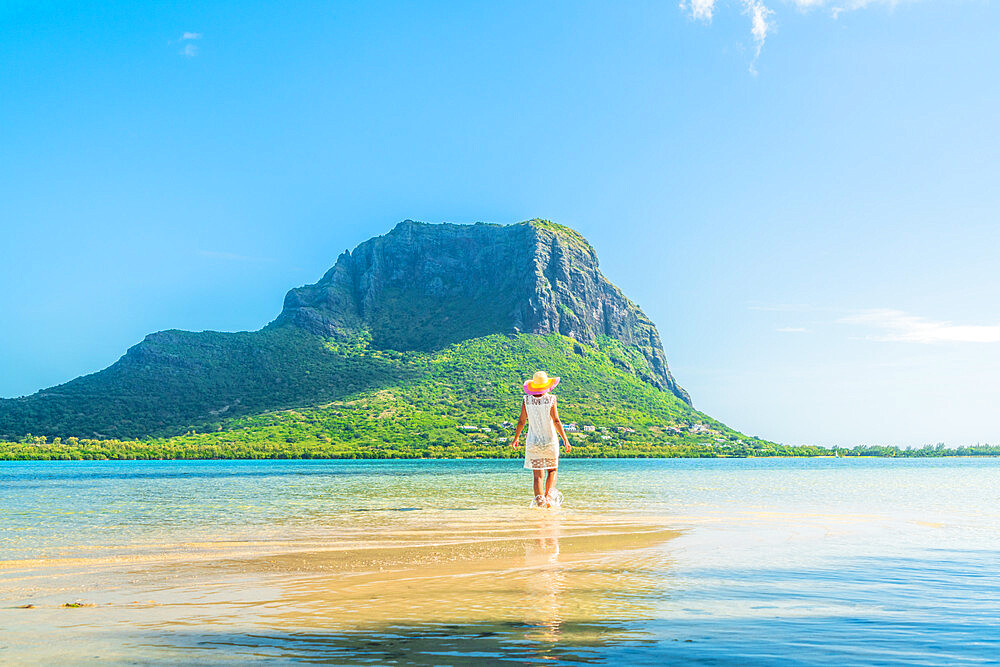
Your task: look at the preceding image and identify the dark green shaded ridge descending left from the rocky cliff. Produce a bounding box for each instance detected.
[0,327,407,440]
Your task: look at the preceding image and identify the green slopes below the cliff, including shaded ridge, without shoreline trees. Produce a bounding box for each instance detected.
[0,327,712,444]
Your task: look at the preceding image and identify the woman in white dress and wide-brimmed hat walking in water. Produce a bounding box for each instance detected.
[510,371,571,507]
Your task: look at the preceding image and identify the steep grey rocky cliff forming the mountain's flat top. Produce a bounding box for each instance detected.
[270,220,691,404]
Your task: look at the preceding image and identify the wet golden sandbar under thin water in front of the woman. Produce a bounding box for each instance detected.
[0,510,678,663]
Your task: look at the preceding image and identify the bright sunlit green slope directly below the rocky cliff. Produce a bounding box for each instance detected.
[152,334,770,457]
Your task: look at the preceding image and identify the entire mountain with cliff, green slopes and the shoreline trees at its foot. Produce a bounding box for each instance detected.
[0,220,1000,460]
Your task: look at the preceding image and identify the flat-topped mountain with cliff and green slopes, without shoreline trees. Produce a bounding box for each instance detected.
[0,220,716,440]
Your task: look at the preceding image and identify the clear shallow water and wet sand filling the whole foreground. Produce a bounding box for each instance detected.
[0,459,1000,665]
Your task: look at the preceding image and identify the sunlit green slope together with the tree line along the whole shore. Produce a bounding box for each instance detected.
[0,334,1000,460]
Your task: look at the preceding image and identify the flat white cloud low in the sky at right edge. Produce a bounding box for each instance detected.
[837,308,1000,344]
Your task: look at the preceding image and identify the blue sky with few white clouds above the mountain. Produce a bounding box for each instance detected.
[0,0,1000,445]
